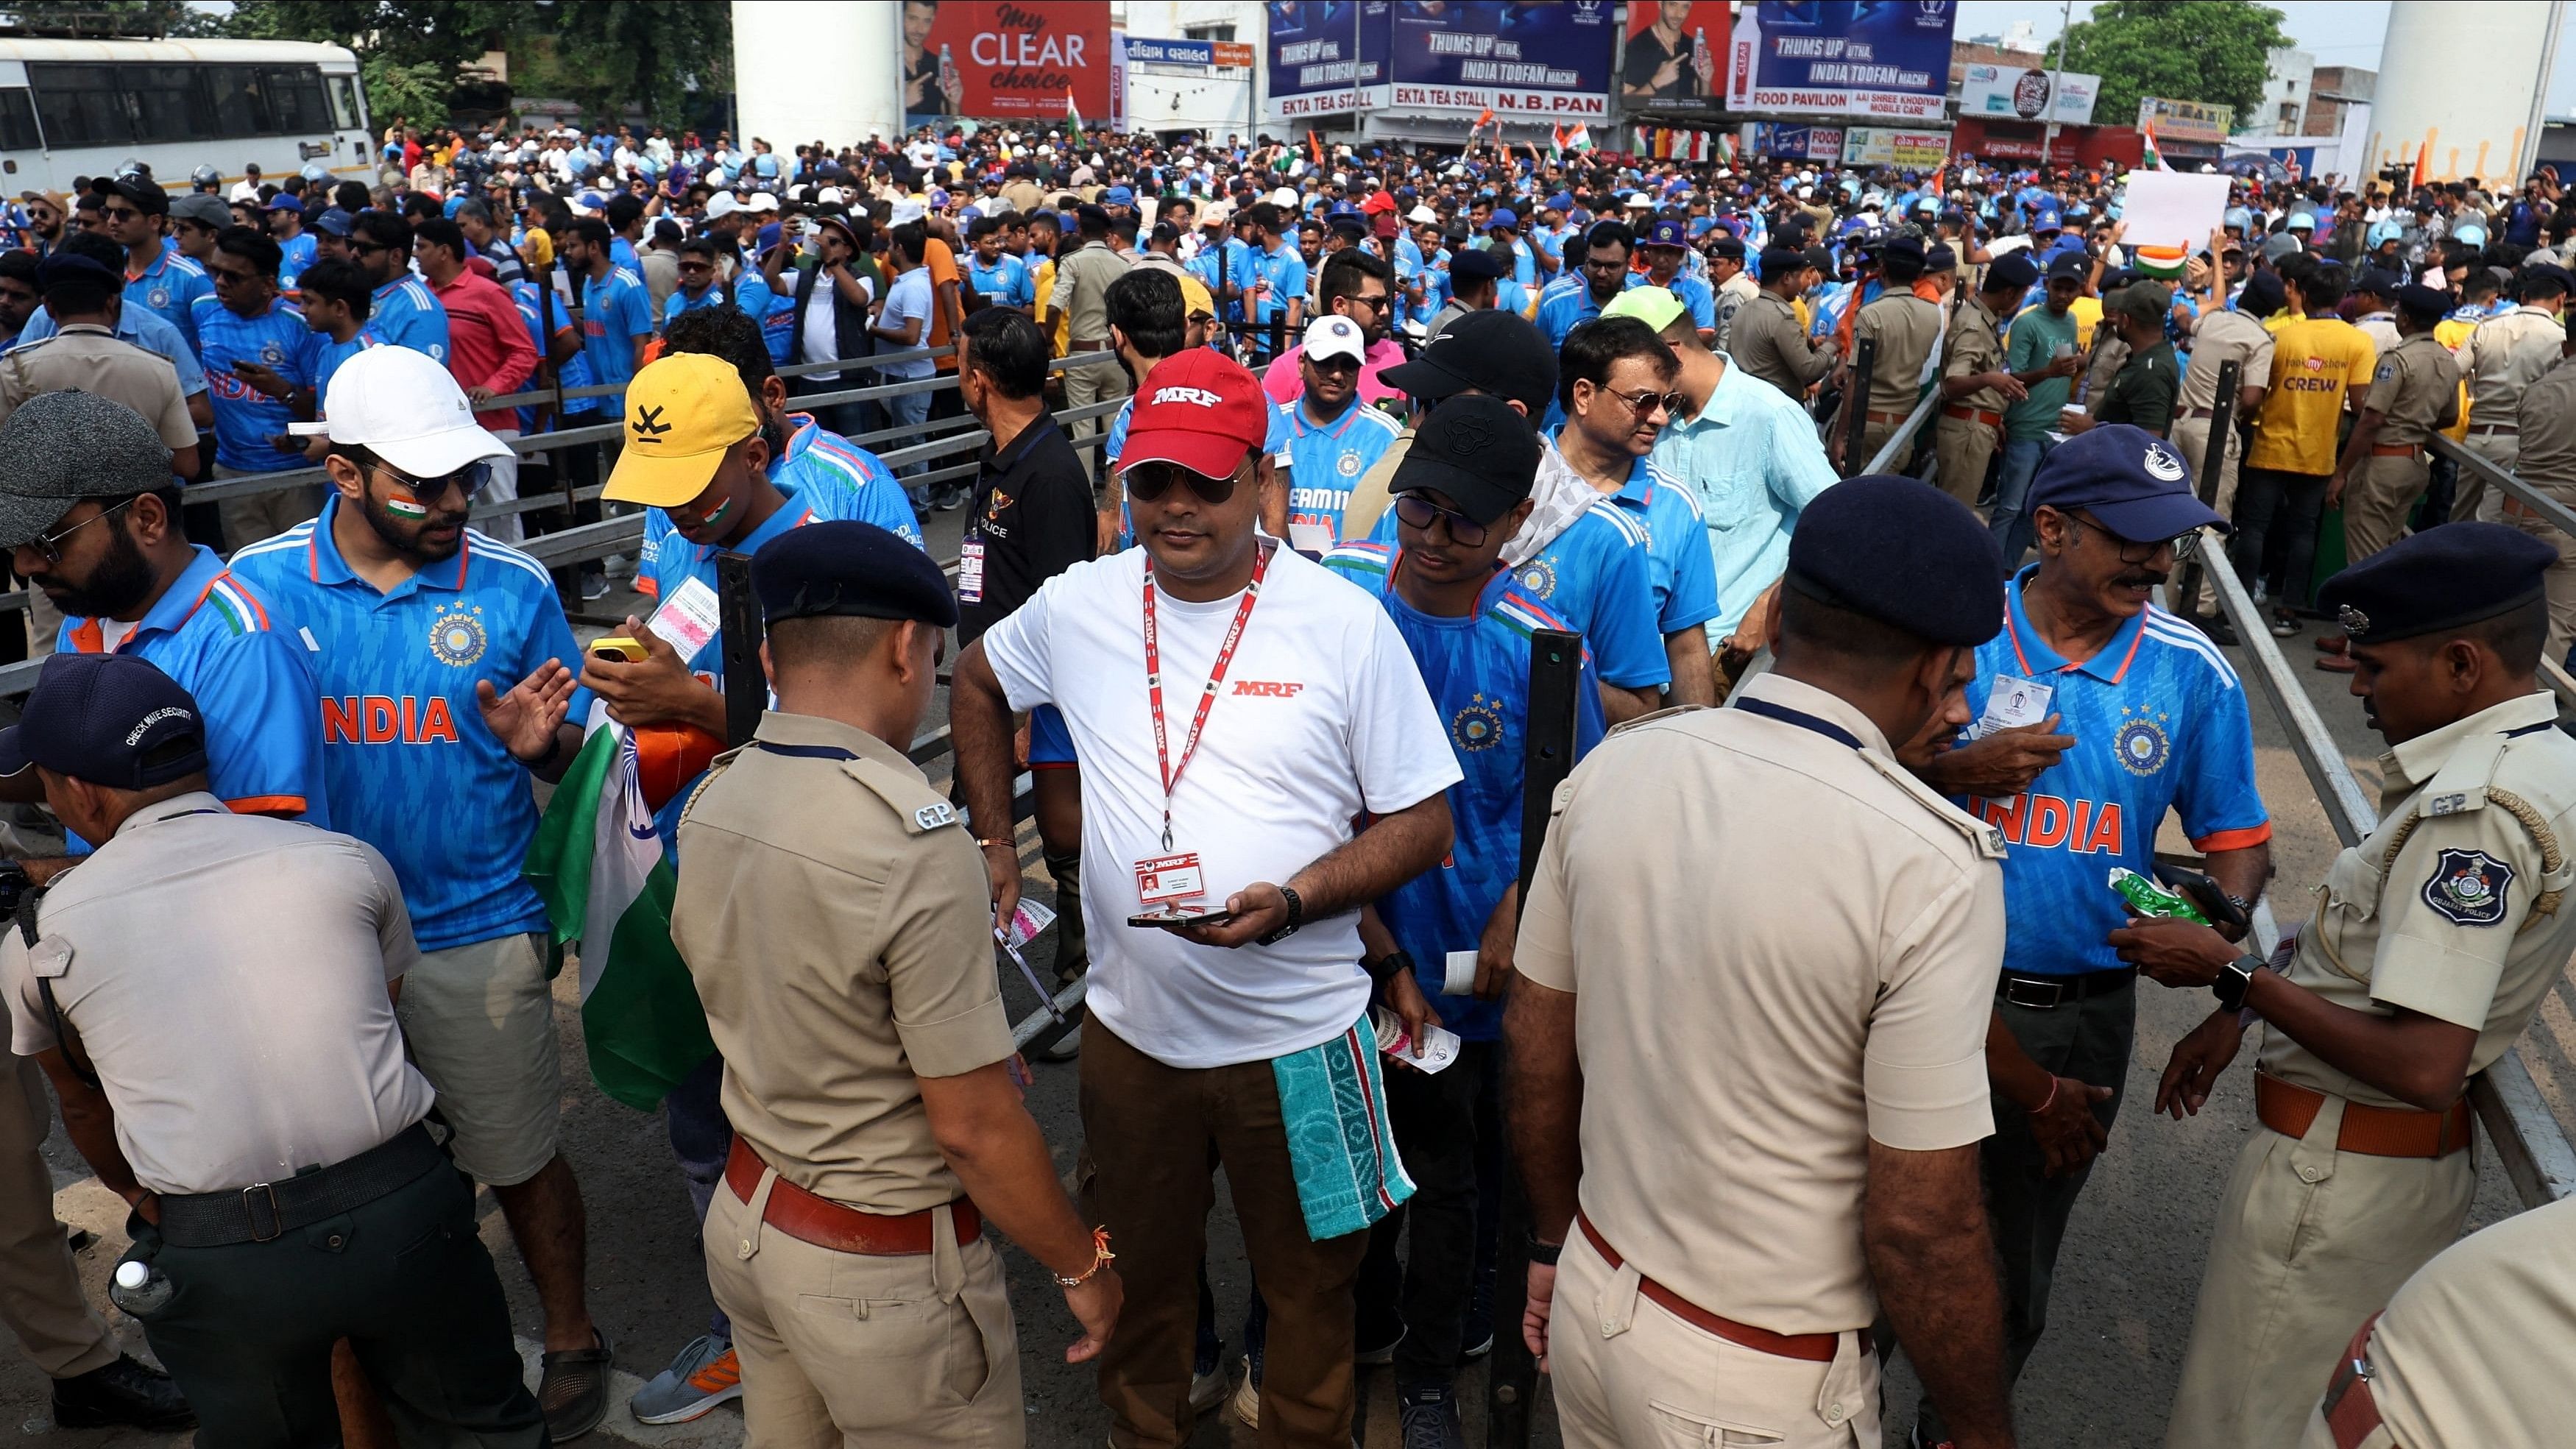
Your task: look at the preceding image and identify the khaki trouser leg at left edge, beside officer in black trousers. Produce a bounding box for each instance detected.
[0,1057,116,1380]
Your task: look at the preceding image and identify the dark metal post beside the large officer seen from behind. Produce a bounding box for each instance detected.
[1484,628,1585,1449]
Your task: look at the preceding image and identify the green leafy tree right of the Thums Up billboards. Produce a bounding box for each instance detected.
[2048,0,2290,126]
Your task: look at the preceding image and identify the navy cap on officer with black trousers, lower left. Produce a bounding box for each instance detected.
[0,659,210,790]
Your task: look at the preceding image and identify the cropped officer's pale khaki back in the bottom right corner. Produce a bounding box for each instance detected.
[2301,1200,2576,1449]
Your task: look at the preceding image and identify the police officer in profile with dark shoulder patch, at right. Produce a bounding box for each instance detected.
[2110,522,2576,1449]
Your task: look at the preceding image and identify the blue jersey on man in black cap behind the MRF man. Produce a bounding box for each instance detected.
[1324,543,1602,1042]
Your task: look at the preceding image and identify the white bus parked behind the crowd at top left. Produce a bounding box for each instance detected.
[0,36,376,196]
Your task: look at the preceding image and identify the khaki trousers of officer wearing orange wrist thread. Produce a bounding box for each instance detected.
[701,1171,1028,1449]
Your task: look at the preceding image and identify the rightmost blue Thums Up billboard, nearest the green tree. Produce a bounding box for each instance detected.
[1726,0,1958,121]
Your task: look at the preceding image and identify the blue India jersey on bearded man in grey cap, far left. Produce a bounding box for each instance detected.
[54,545,333,854]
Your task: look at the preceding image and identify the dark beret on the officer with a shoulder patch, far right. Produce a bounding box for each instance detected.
[2316,522,2558,643]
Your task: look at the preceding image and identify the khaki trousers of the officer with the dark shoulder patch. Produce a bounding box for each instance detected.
[2164,1097,2478,1449]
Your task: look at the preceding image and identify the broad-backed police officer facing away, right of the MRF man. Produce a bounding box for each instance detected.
[1504,476,2012,1449]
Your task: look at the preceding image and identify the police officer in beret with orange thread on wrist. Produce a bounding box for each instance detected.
[670,520,1121,1449]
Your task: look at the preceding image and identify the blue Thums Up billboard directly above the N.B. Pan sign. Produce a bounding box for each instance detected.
[1386,0,1618,121]
